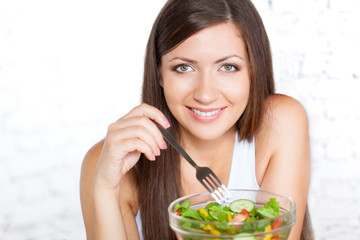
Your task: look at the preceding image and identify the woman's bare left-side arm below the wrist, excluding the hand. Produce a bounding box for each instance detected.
[80,141,139,240]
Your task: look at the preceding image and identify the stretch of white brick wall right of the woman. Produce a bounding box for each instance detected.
[255,0,360,240]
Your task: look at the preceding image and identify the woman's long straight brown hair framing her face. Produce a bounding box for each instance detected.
[136,0,306,240]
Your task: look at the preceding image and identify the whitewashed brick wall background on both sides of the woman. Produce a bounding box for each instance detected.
[0,0,360,240]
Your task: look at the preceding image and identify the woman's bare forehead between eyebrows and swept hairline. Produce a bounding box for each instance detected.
[163,22,247,61]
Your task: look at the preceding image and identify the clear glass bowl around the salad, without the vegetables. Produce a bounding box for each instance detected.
[168,189,296,240]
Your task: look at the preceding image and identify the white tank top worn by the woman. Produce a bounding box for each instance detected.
[135,133,260,240]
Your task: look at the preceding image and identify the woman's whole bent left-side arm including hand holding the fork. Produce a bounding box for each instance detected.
[80,104,170,240]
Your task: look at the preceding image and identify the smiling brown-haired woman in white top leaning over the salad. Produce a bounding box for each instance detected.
[81,0,310,240]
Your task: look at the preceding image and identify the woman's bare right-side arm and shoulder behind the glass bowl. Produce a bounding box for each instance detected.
[261,95,310,240]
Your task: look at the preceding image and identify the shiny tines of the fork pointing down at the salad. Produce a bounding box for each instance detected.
[201,172,231,204]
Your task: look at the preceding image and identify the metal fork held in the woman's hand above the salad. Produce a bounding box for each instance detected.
[158,126,231,204]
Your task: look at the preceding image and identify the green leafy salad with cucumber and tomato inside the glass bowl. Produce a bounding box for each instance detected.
[174,198,288,240]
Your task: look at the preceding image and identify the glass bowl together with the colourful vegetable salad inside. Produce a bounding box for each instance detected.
[168,189,295,240]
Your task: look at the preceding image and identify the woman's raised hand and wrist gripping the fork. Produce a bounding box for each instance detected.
[93,104,170,193]
